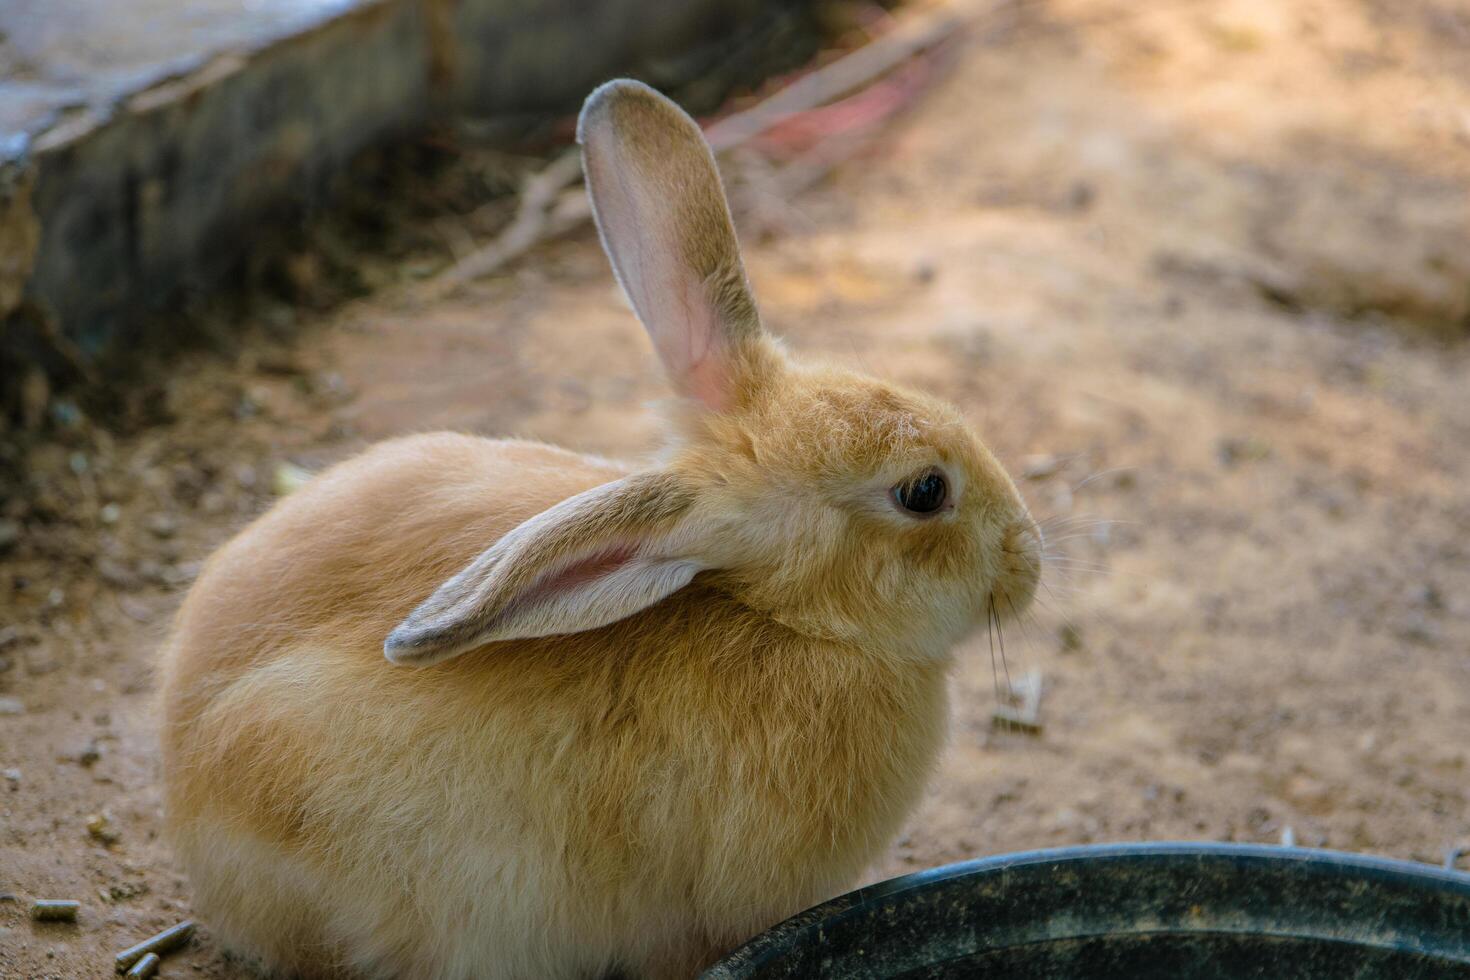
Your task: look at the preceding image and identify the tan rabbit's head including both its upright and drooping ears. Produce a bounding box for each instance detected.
[385,81,1041,664]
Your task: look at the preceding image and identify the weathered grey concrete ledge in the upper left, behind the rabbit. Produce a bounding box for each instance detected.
[0,0,801,359]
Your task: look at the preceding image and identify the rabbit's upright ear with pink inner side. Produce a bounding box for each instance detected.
[576,79,760,411]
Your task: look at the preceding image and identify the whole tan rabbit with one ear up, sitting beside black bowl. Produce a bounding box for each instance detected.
[160,81,1041,980]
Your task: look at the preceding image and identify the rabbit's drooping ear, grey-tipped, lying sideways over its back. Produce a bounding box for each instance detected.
[384,472,710,666]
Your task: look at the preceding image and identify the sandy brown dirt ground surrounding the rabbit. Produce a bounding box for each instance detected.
[0,0,1470,977]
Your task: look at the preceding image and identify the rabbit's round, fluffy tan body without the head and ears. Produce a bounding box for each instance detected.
[163,433,945,980]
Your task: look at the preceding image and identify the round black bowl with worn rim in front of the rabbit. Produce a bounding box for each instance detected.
[704,843,1470,980]
